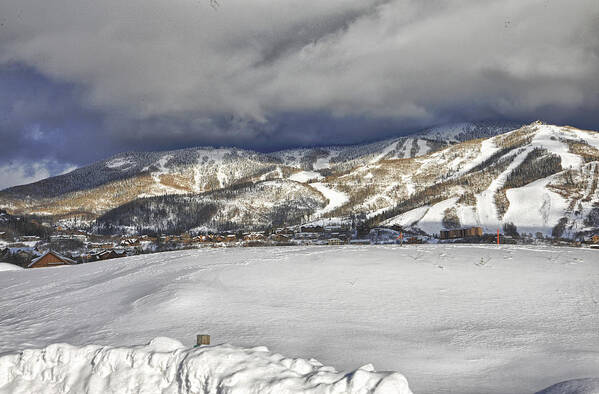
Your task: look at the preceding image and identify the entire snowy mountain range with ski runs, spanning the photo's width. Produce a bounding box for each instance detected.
[0,122,599,236]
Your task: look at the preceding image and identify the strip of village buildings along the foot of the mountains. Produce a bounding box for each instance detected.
[0,222,599,268]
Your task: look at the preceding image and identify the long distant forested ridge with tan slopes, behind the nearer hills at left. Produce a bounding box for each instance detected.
[0,123,508,218]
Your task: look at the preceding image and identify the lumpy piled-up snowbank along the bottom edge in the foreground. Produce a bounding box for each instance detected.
[0,338,411,394]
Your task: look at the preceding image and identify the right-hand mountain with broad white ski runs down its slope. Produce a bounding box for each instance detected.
[376,123,599,237]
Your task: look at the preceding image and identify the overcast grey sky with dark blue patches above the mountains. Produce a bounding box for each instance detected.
[0,0,599,189]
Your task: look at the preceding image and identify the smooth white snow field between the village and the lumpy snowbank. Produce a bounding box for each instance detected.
[0,245,599,394]
